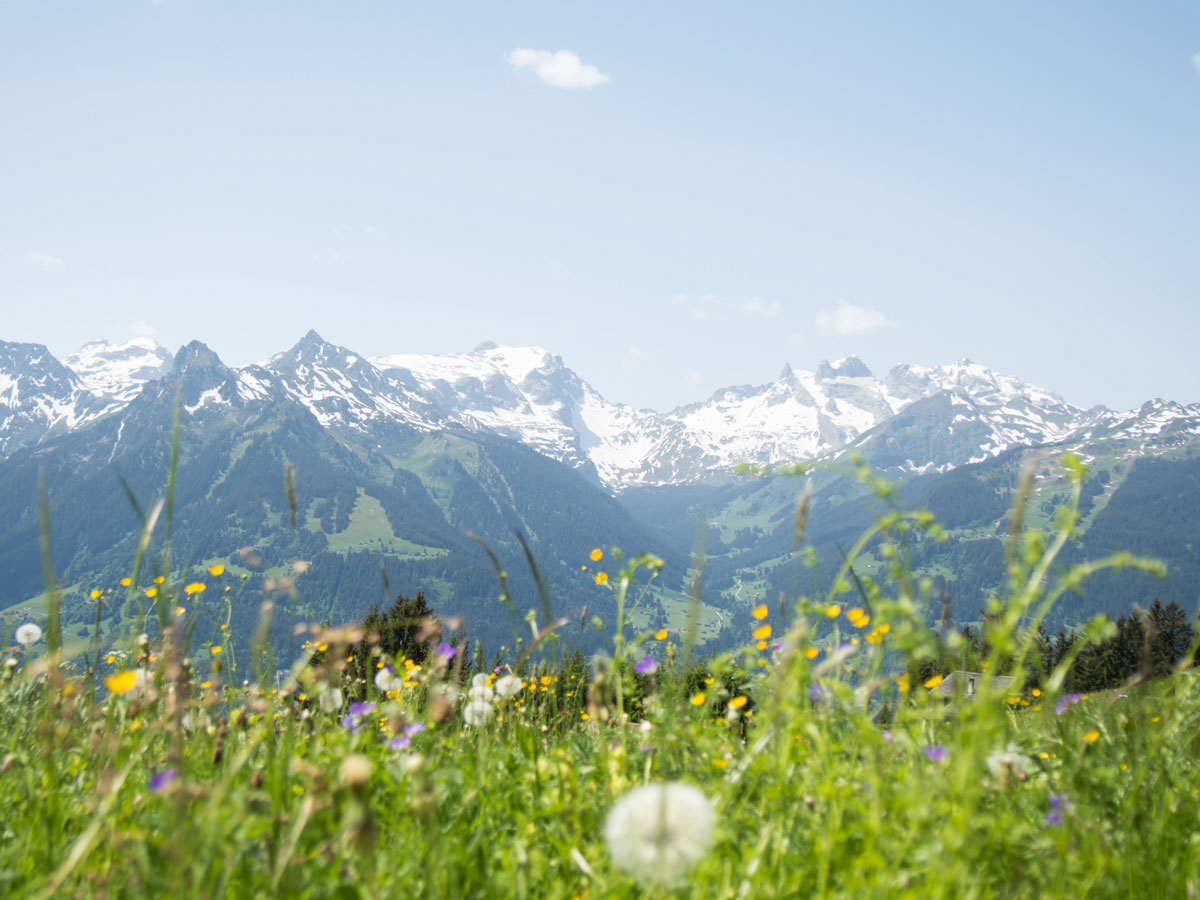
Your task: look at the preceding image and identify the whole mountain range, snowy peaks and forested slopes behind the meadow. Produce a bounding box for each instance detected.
[0,331,1200,650]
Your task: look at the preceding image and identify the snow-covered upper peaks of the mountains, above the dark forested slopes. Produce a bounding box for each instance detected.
[0,331,1200,492]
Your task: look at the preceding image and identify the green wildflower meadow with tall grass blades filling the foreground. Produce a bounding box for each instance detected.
[0,461,1200,899]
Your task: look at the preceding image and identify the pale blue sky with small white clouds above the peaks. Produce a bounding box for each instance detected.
[0,0,1200,408]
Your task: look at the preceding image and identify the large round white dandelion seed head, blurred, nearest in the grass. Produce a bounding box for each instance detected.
[604,781,716,884]
